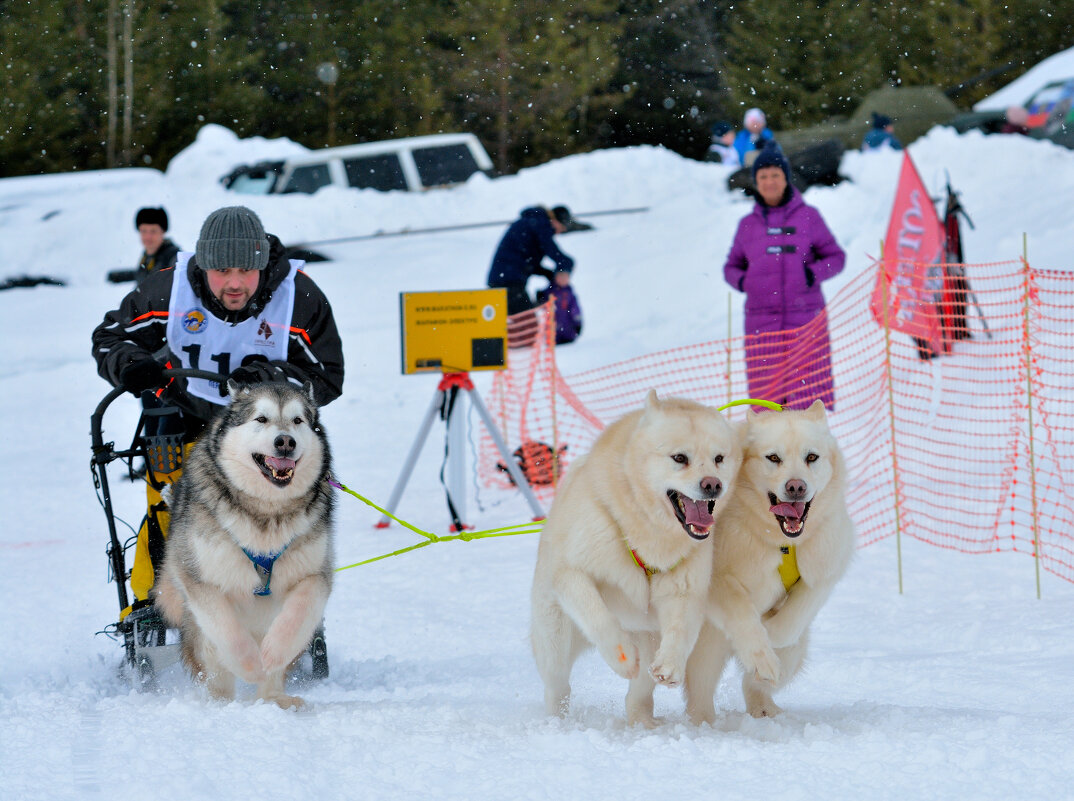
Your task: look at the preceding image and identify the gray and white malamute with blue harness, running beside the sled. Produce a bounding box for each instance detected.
[156,382,333,709]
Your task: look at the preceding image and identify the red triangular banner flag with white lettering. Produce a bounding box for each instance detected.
[870,152,944,353]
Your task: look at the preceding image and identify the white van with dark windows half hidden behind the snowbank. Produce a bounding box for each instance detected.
[220,133,493,194]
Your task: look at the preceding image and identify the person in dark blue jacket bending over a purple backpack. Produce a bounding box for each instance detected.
[488,206,578,315]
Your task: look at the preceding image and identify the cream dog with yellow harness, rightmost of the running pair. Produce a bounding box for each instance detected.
[685,401,854,724]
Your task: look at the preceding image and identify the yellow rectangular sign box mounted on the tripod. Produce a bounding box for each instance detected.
[400,289,507,375]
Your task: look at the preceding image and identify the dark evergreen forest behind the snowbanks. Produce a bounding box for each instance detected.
[0,0,1074,177]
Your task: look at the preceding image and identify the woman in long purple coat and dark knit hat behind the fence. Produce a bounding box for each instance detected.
[724,144,846,409]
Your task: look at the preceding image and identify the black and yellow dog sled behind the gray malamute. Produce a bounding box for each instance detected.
[90,369,329,689]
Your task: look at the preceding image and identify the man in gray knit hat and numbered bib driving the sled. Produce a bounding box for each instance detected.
[92,206,344,433]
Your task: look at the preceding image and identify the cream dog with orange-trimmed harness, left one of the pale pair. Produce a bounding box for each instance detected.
[531,392,741,725]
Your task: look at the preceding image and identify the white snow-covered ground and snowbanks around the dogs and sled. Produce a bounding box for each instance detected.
[0,127,1074,801]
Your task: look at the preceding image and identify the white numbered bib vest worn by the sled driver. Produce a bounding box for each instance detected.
[168,253,303,406]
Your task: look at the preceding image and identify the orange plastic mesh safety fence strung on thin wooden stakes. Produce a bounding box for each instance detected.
[478,261,1074,582]
